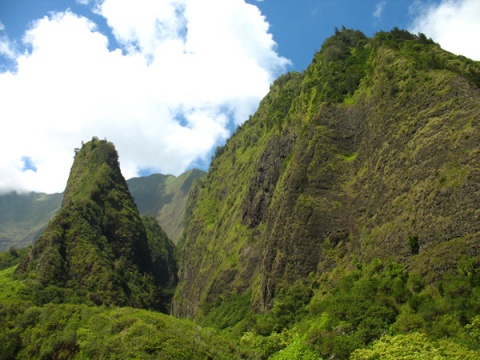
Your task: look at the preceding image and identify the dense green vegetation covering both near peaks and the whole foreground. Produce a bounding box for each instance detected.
[0,28,480,360]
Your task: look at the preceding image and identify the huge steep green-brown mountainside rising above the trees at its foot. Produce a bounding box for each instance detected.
[174,29,480,318]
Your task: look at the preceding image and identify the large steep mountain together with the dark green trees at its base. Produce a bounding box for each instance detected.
[173,29,480,358]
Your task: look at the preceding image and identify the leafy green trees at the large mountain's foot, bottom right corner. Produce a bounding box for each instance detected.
[297,258,480,359]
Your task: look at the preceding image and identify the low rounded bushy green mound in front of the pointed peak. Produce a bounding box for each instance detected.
[0,301,242,359]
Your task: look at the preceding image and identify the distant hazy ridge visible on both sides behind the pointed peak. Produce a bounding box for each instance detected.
[0,169,205,251]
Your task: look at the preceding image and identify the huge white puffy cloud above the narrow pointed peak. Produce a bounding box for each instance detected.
[0,0,289,192]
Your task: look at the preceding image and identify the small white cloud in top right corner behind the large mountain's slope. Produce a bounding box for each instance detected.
[410,0,480,60]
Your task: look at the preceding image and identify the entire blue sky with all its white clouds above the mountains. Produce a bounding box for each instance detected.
[0,0,480,194]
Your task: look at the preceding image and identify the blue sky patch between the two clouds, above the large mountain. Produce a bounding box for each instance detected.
[249,0,412,70]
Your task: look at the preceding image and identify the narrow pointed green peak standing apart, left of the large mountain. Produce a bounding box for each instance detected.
[16,138,174,310]
